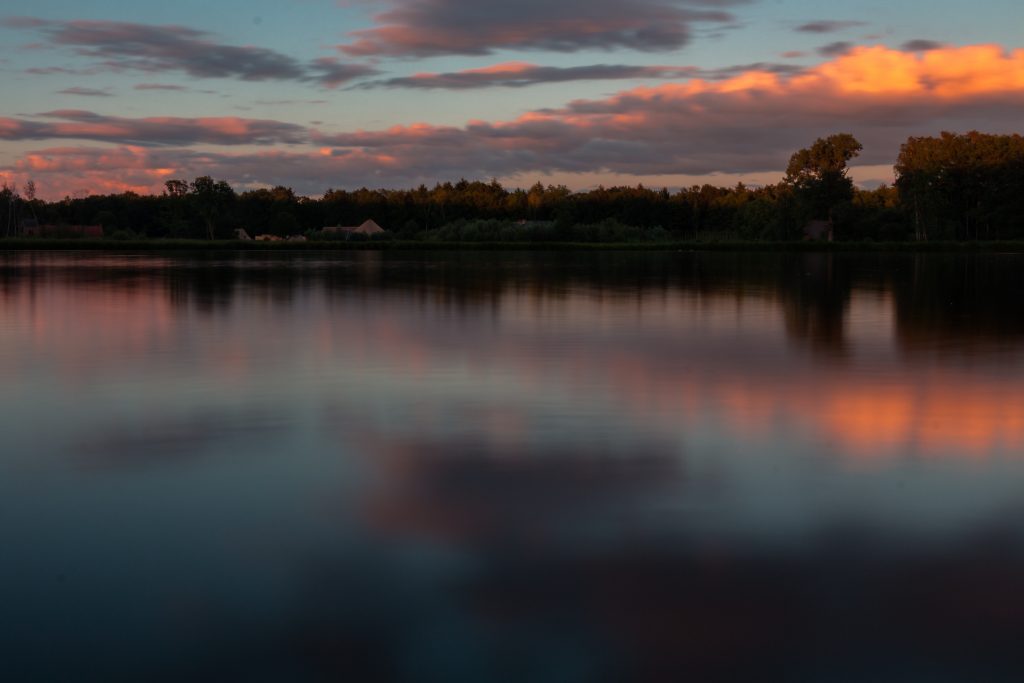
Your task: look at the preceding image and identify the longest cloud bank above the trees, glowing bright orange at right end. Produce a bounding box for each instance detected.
[0,45,1024,198]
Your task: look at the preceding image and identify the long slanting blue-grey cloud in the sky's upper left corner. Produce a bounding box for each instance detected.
[2,17,376,87]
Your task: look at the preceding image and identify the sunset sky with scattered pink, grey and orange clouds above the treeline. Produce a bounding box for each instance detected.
[0,0,1024,200]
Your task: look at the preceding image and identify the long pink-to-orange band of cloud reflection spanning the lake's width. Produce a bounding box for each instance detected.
[8,258,1024,462]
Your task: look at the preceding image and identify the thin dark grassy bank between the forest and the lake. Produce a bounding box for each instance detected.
[6,239,1024,253]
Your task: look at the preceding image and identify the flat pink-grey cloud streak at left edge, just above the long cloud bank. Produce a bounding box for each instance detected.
[0,110,307,146]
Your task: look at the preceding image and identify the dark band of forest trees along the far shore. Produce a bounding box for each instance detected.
[0,131,1024,243]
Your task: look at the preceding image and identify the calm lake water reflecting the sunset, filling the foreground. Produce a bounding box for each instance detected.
[0,253,1024,682]
